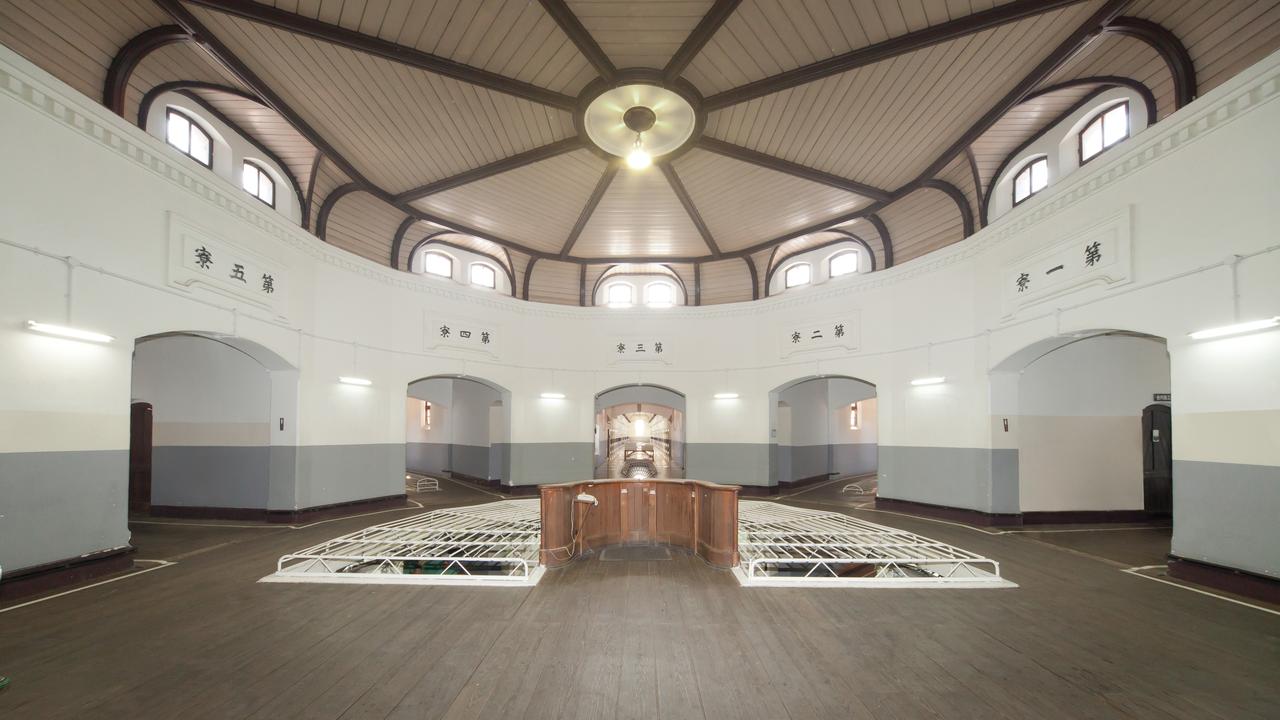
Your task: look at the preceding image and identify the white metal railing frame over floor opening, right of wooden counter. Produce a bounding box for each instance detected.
[733,500,1018,588]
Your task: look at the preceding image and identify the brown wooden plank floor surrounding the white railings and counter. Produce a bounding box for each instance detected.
[0,476,1280,720]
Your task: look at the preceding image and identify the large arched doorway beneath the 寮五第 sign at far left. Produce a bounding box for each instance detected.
[129,332,298,519]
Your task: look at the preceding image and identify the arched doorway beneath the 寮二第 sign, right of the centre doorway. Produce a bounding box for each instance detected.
[769,375,879,489]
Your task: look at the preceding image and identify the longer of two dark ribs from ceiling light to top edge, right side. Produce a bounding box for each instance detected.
[703,0,1082,111]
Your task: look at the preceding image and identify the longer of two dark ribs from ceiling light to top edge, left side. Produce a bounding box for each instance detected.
[175,0,577,110]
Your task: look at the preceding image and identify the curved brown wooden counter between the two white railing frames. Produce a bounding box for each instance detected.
[539,479,739,568]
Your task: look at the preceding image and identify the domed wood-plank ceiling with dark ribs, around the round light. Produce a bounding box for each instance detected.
[0,0,1280,304]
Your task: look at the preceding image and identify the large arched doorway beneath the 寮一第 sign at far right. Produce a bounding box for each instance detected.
[991,329,1172,523]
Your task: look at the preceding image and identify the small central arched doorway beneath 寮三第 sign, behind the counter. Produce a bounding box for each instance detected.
[594,384,685,479]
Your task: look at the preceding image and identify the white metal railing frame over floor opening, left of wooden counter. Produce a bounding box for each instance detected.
[262,500,543,585]
